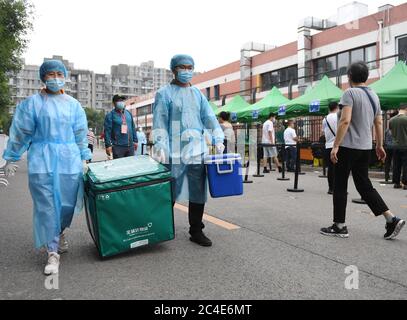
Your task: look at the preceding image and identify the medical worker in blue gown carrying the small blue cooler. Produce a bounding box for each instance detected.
[153,55,225,247]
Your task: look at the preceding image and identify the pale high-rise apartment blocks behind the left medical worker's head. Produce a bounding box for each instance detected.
[9,56,172,112]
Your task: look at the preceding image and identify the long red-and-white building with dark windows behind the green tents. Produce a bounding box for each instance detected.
[131,2,407,130]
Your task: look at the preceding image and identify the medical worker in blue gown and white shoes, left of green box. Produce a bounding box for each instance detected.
[3,60,91,275]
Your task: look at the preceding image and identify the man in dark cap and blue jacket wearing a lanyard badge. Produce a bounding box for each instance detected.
[104,95,138,159]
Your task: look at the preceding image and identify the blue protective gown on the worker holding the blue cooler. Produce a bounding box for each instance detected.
[153,84,224,204]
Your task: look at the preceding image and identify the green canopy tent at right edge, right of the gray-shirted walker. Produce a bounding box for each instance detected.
[369,61,407,110]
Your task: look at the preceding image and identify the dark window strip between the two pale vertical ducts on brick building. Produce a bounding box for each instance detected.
[261,65,298,91]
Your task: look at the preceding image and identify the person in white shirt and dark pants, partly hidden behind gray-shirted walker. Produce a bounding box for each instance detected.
[322,102,339,194]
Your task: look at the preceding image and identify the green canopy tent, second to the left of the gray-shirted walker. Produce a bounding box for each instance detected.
[237,87,290,123]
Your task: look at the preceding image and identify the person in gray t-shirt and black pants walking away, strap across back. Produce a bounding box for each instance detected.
[321,62,405,240]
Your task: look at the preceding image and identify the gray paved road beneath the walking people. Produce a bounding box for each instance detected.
[0,152,407,300]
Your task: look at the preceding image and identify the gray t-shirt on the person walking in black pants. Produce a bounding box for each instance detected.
[339,88,381,150]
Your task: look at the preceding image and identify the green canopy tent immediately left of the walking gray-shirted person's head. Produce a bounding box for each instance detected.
[278,76,343,118]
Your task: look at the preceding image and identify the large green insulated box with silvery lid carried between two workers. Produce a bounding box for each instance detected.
[84,156,175,257]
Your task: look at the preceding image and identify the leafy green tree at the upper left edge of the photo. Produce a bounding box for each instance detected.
[0,0,34,131]
